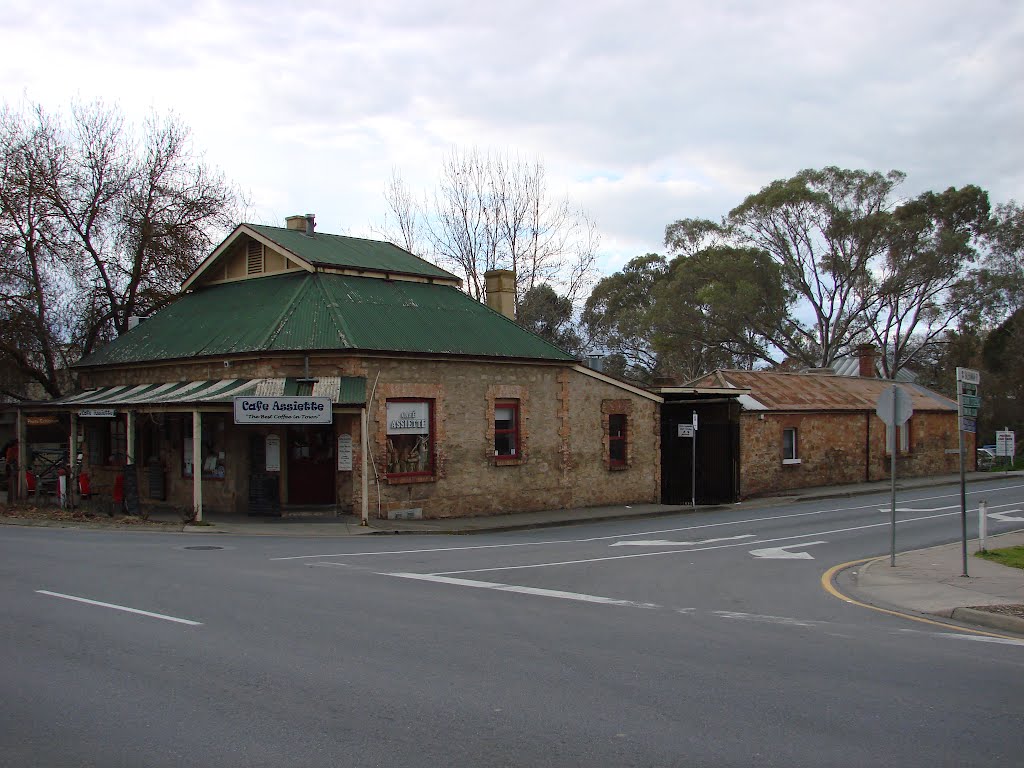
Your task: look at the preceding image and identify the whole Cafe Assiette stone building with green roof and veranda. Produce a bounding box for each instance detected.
[14,215,660,517]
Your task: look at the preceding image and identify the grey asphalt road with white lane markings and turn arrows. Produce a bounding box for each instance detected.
[0,482,1024,768]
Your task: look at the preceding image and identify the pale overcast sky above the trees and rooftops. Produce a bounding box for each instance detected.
[0,0,1024,273]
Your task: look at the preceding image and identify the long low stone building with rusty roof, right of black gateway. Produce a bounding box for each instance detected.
[689,368,975,498]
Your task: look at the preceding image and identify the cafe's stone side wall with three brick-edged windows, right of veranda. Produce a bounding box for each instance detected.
[368,360,659,517]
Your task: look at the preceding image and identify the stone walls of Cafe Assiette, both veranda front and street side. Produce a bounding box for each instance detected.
[77,354,659,517]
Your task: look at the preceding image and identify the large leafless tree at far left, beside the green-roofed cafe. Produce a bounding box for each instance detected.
[0,103,241,395]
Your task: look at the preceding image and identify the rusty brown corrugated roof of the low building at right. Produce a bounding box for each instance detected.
[689,371,956,412]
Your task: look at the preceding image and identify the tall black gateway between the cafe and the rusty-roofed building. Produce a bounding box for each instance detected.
[662,401,739,504]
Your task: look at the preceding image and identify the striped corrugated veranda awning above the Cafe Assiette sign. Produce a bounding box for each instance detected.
[26,376,367,411]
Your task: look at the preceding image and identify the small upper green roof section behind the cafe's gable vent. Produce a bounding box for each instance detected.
[244,224,459,280]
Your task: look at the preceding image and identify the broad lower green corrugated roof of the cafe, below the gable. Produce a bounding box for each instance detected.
[78,272,574,367]
